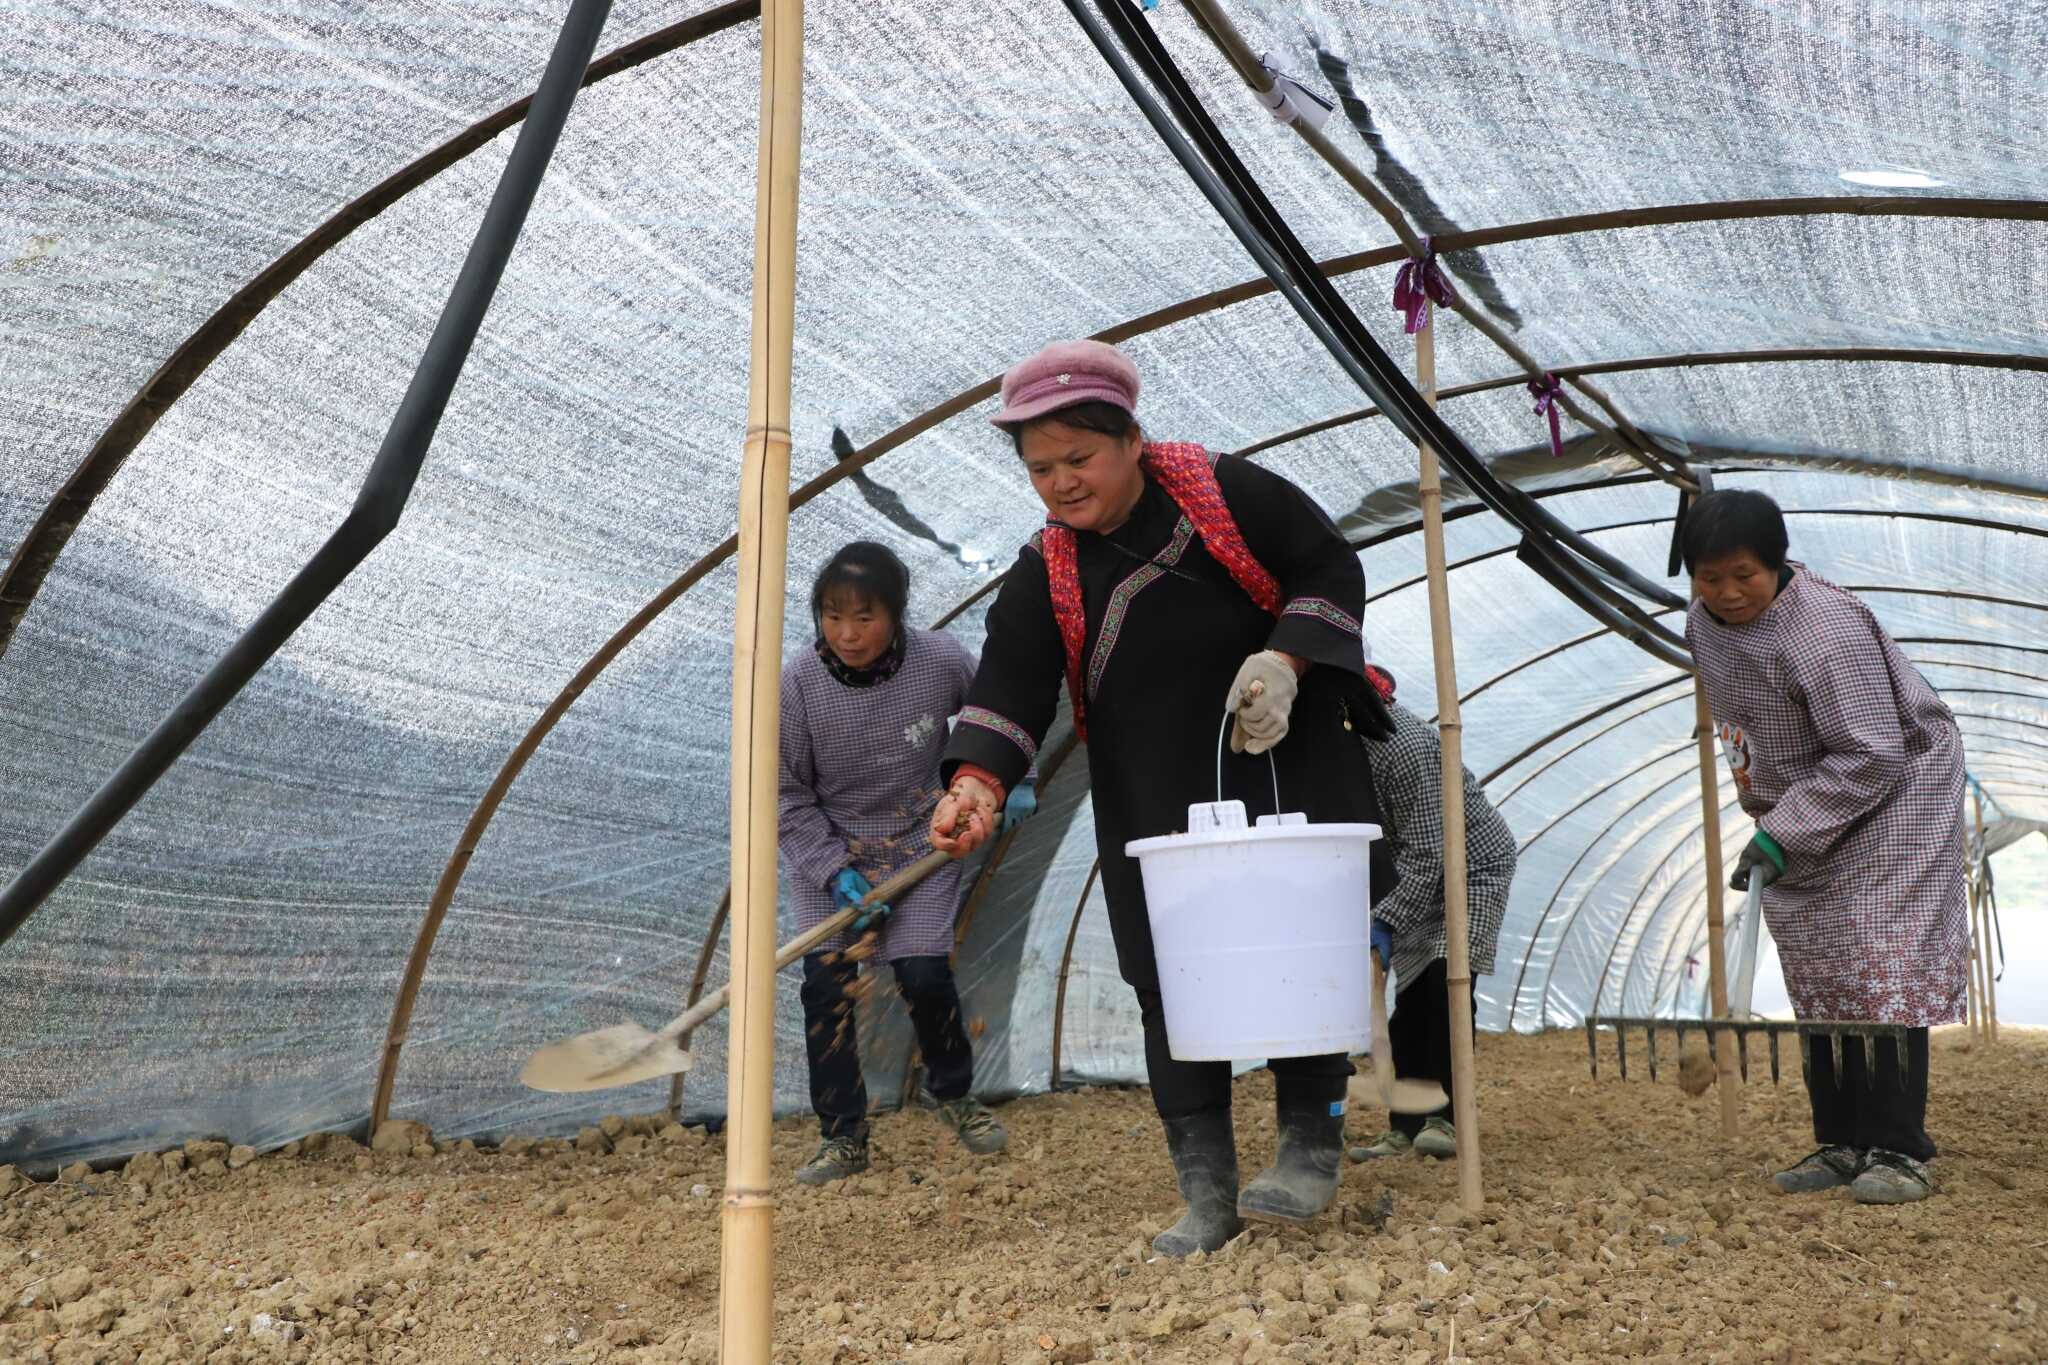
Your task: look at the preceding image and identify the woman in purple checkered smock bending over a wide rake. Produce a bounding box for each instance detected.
[1681,489,1968,1203]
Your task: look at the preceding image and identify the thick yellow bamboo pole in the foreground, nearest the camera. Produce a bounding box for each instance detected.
[719,0,803,1365]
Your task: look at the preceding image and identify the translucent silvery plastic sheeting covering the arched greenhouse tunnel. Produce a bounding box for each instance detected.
[0,0,2048,1162]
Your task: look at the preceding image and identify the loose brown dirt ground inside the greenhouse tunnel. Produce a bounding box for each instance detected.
[0,1029,2048,1365]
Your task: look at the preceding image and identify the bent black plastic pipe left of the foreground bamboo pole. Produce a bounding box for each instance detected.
[0,0,612,943]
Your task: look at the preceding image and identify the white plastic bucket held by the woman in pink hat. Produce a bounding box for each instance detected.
[1124,800,1380,1062]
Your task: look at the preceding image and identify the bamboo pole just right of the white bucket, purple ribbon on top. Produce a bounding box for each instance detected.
[1417,317,1485,1212]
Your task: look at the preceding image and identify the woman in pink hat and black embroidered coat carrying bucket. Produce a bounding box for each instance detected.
[932,342,1393,1257]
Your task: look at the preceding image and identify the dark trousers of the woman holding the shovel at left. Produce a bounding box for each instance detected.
[803,954,975,1142]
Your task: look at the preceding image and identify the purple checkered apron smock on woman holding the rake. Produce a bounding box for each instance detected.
[1686,565,1968,1025]
